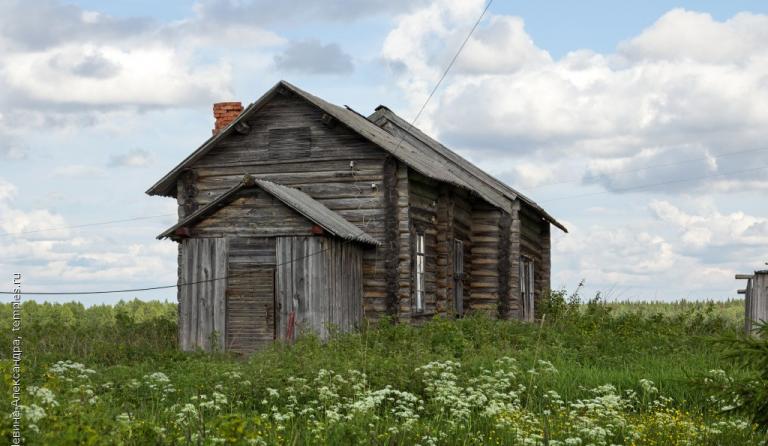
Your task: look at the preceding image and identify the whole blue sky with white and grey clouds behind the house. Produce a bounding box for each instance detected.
[0,0,768,303]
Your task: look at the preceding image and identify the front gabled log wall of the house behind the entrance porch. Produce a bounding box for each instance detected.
[177,92,390,318]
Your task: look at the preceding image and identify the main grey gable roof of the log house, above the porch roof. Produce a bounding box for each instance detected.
[147,81,567,232]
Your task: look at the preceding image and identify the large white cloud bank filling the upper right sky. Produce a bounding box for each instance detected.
[382,4,768,192]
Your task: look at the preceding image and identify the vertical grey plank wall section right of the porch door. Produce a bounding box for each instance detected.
[276,237,363,339]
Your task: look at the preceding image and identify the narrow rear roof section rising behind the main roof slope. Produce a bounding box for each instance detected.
[368,105,568,232]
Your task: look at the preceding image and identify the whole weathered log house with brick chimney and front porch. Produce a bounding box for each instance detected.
[147,81,566,352]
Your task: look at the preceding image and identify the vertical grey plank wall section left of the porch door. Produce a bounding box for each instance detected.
[179,238,228,351]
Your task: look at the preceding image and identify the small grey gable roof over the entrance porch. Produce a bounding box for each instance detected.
[157,175,380,245]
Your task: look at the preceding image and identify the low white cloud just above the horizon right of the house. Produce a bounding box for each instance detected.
[553,197,768,299]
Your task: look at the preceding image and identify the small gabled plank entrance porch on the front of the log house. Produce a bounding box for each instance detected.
[160,176,379,353]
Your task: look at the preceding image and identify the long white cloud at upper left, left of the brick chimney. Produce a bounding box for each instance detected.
[0,44,231,107]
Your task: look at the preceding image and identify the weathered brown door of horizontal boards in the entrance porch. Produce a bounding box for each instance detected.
[226,265,275,353]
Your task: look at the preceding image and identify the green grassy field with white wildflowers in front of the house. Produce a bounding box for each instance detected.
[0,299,765,446]
